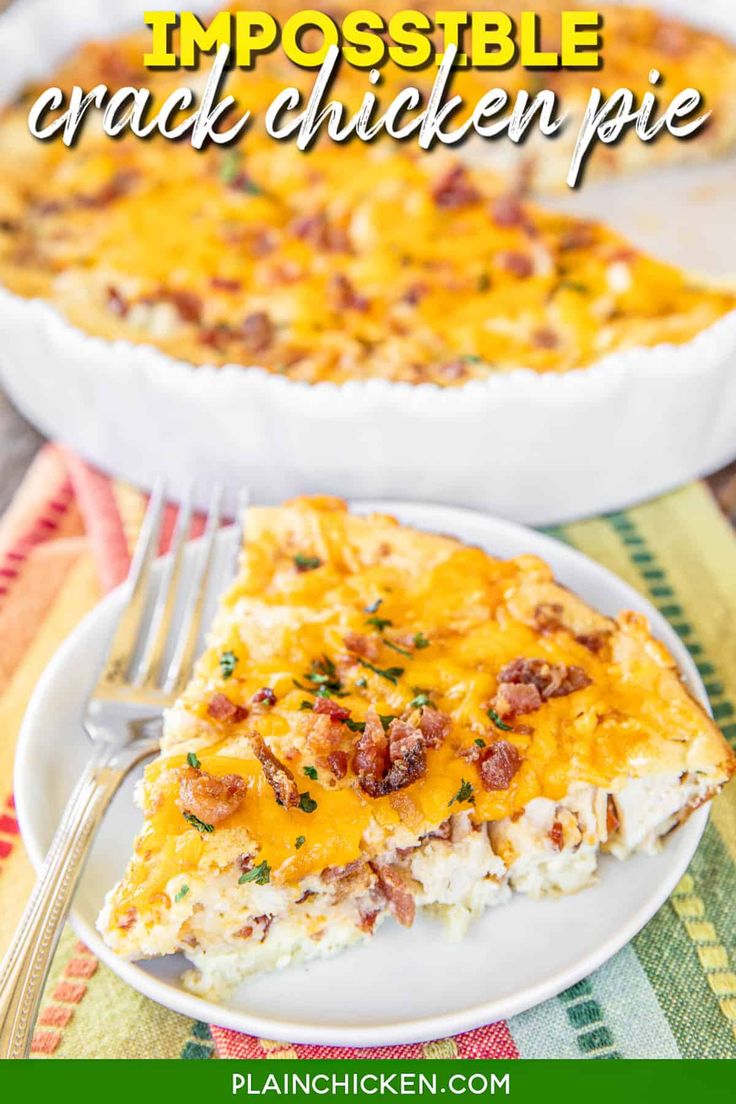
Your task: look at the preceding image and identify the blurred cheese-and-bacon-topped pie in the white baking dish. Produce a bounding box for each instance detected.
[0,9,736,386]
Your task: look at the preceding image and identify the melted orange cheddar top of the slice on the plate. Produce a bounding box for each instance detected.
[110,499,734,926]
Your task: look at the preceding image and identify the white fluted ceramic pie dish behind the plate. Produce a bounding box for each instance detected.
[0,0,736,524]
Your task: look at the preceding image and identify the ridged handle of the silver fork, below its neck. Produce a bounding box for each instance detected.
[0,746,135,1059]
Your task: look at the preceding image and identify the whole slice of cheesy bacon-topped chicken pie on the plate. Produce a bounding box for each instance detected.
[99,498,735,997]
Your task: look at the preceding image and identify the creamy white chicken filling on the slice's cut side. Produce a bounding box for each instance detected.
[170,774,713,996]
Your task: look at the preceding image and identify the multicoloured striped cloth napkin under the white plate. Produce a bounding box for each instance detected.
[0,446,736,1059]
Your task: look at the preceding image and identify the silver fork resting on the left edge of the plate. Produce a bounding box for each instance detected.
[0,486,235,1059]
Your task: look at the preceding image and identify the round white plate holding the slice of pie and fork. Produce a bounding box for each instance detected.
[15,502,707,1047]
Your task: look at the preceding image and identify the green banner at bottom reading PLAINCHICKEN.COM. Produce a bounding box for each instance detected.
[0,1059,736,1104]
